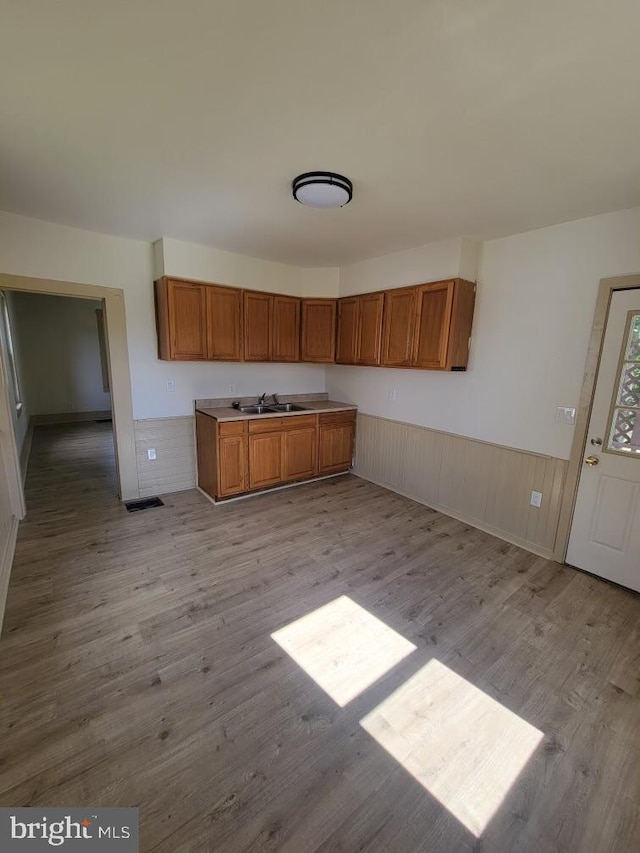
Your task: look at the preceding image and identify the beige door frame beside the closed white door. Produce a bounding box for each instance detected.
[553,275,640,563]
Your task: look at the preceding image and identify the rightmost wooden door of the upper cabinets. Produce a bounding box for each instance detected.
[412,281,455,370]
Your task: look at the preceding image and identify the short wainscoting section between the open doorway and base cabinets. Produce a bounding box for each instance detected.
[135,415,196,498]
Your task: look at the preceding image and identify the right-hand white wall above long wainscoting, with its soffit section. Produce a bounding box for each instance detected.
[327,208,640,459]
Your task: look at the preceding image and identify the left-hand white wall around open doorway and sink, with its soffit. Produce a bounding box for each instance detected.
[0,212,328,419]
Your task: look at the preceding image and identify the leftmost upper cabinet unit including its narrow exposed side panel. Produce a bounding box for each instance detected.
[155,279,207,361]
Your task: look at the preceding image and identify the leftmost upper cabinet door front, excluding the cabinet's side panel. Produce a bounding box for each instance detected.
[165,279,207,361]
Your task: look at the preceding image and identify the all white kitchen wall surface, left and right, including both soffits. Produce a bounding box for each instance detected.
[0,208,640,458]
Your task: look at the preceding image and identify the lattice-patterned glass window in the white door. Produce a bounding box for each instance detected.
[607,312,640,454]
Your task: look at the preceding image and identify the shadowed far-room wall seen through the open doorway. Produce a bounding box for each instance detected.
[12,292,111,415]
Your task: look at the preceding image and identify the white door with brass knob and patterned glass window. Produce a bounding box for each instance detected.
[567,289,640,591]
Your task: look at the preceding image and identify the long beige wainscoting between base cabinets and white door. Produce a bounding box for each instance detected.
[353,414,568,557]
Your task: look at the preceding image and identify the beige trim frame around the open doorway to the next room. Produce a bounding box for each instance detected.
[0,273,140,501]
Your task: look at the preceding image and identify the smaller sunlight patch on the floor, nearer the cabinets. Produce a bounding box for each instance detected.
[271,595,416,708]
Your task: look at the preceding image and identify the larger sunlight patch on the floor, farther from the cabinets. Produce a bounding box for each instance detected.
[361,659,543,837]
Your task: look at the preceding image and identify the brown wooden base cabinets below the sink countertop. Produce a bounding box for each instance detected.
[196,410,356,499]
